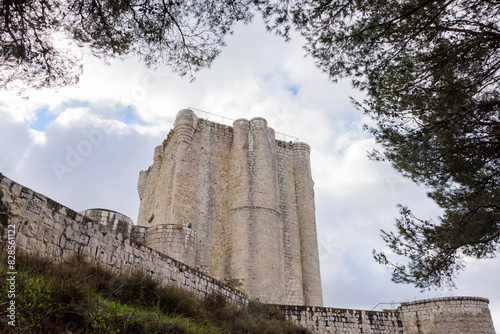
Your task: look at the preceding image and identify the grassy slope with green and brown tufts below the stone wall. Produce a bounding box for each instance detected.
[0,250,308,334]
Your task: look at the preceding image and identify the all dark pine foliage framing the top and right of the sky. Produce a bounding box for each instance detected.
[0,0,500,288]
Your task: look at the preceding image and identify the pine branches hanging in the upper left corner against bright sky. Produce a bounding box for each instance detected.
[0,0,252,88]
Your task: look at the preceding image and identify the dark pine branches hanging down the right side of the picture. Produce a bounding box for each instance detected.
[260,0,500,288]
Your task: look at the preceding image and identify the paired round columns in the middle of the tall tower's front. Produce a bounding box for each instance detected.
[228,118,286,303]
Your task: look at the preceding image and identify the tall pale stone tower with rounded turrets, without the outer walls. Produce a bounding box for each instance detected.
[137,109,323,306]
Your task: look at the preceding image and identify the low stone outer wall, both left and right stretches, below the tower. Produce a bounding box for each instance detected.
[0,173,495,334]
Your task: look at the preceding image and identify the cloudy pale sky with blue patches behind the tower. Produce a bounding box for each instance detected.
[0,15,500,333]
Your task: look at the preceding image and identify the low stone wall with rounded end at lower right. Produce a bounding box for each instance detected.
[278,297,495,334]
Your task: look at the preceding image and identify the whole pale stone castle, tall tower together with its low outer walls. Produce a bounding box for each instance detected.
[0,110,495,334]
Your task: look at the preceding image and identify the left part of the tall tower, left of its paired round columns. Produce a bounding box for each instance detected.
[137,112,233,280]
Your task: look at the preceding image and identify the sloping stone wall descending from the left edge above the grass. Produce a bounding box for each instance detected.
[0,174,247,305]
